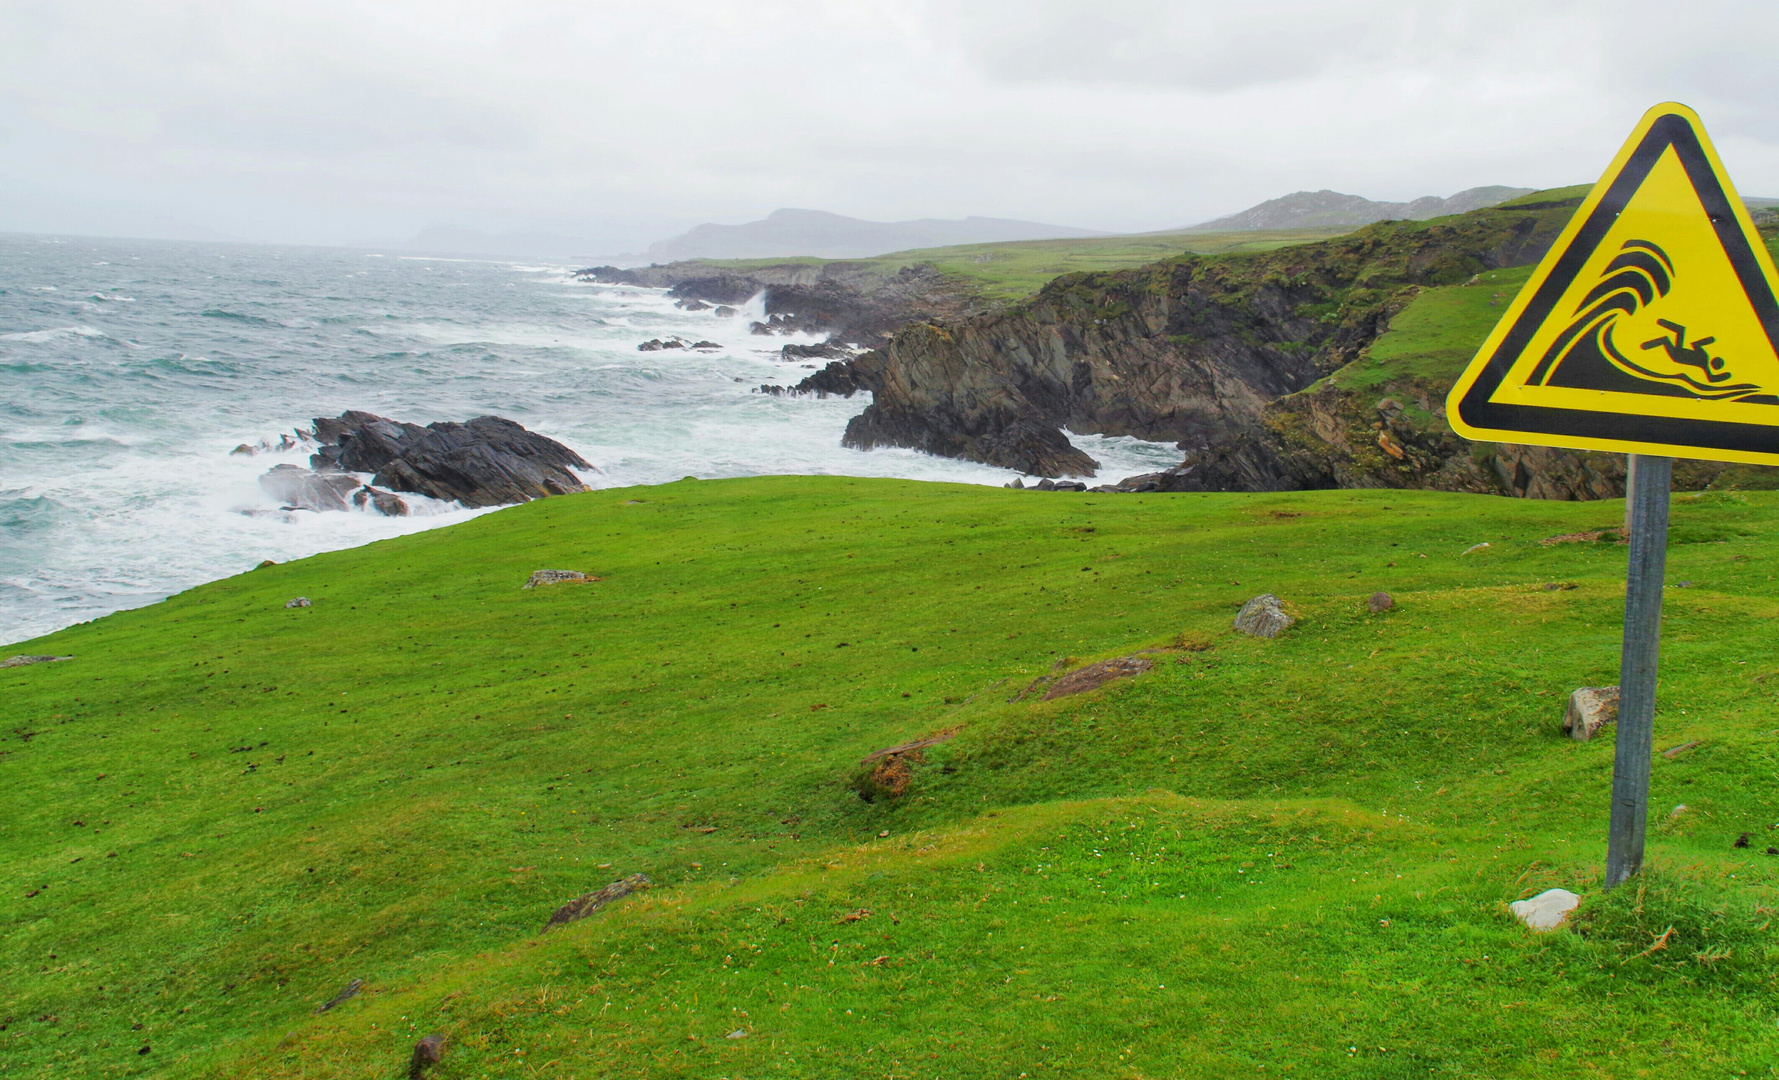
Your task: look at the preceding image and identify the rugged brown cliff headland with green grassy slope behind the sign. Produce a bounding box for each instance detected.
[845,187,1779,498]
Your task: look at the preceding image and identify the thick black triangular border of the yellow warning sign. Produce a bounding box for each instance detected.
[1459,112,1779,457]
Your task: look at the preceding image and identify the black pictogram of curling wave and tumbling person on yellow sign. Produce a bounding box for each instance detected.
[1526,240,1767,400]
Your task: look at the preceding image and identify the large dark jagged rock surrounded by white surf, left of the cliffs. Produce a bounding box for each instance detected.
[304,411,598,512]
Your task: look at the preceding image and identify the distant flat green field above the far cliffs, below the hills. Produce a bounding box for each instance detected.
[679,228,1352,301]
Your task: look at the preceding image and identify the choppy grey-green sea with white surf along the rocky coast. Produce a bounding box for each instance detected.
[0,235,1179,644]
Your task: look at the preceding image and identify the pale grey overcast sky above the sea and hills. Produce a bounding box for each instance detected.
[0,0,1779,253]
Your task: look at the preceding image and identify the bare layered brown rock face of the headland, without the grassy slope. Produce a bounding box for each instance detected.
[845,197,1580,488]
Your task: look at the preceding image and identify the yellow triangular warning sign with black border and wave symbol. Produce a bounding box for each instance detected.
[1446,103,1779,464]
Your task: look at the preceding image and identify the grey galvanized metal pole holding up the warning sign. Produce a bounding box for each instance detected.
[1606,454,1674,888]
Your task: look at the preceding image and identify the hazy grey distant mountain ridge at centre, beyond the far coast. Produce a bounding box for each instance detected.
[648,210,1108,262]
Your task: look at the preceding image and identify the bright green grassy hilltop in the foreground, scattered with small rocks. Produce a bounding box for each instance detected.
[0,479,1779,1080]
